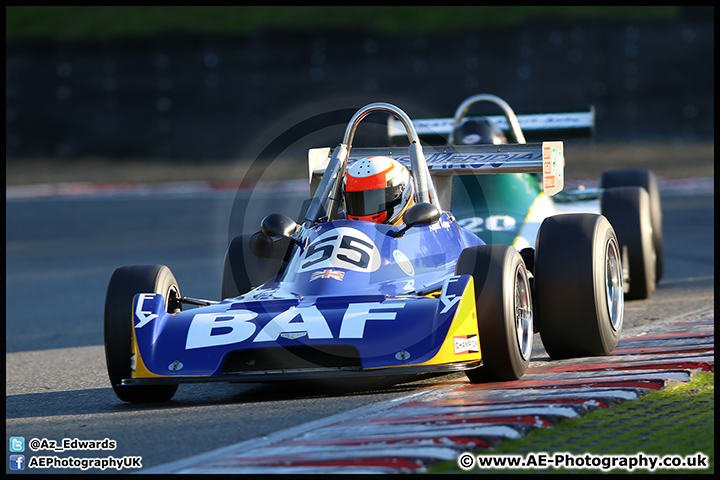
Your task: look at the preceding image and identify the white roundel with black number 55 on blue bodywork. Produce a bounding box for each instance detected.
[299,227,380,272]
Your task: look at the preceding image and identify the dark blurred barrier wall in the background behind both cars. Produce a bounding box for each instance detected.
[6,18,714,160]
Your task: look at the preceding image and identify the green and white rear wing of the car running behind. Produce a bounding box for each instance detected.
[388,107,595,144]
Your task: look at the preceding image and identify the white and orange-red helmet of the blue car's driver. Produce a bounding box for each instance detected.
[343,156,415,225]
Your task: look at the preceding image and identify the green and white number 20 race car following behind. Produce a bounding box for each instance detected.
[388,94,663,299]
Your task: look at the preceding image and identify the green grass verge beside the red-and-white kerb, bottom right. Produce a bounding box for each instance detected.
[428,372,715,474]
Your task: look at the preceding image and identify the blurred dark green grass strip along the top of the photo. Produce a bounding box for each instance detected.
[5,5,680,39]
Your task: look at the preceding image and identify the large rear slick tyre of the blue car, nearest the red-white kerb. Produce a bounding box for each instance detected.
[534,213,624,359]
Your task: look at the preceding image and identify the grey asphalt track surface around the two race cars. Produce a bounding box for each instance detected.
[6,182,714,473]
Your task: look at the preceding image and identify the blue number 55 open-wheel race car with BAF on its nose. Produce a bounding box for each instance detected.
[105,103,623,402]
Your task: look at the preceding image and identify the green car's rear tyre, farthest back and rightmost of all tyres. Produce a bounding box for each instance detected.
[599,168,664,282]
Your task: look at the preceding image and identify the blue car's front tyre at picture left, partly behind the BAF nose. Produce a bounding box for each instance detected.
[104,265,182,403]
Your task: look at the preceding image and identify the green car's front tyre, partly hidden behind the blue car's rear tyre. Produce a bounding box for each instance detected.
[600,187,657,300]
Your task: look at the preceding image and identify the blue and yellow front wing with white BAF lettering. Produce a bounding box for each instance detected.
[122,275,482,385]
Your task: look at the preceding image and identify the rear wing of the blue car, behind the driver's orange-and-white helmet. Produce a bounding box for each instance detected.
[308,142,565,209]
